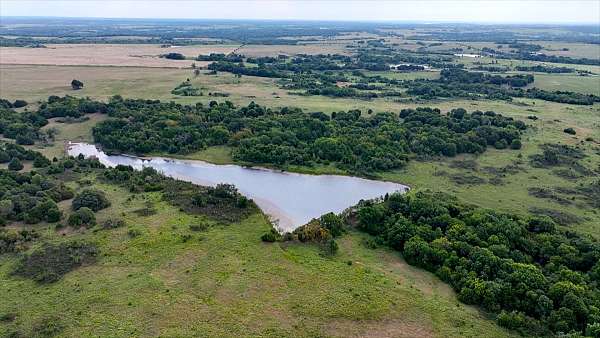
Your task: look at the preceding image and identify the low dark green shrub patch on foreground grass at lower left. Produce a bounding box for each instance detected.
[13,241,97,283]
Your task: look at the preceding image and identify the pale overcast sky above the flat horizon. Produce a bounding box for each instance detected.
[0,0,600,24]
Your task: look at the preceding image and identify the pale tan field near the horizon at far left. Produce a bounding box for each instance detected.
[0,44,238,68]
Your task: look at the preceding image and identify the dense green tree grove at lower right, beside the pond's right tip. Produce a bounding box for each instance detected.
[348,191,600,336]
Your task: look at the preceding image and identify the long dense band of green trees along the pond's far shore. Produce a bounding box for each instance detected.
[93,98,525,172]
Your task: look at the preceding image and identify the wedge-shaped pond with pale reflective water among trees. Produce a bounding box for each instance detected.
[68,143,409,231]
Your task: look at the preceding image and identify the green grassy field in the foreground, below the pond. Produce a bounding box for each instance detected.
[0,177,510,337]
